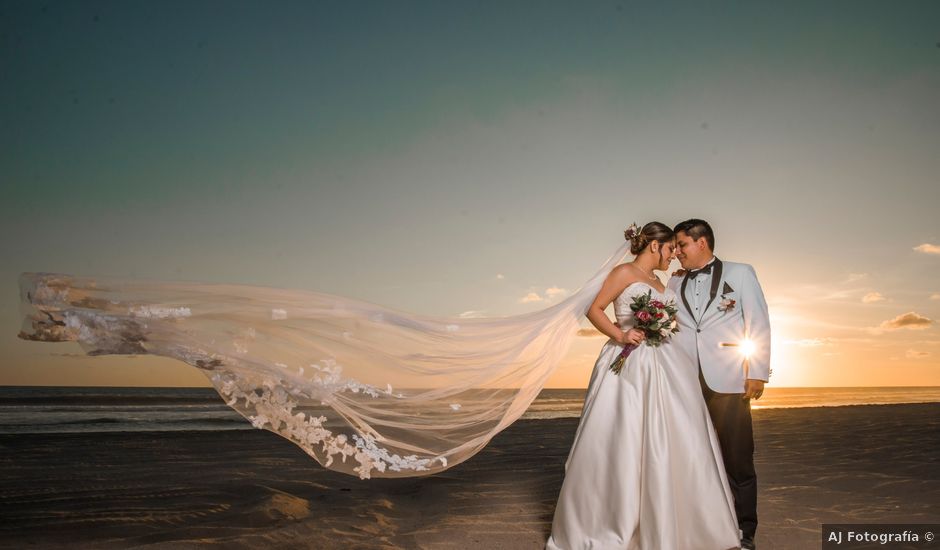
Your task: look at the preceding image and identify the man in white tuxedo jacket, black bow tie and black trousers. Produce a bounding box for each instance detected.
[669,219,770,549]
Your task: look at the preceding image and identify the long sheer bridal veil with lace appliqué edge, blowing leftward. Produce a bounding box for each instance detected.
[19,242,630,479]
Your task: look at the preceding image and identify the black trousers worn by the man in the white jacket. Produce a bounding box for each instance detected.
[698,365,757,538]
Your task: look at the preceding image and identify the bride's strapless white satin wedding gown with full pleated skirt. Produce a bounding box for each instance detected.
[546,282,740,550]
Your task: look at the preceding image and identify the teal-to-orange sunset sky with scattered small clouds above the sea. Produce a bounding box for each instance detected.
[0,0,940,387]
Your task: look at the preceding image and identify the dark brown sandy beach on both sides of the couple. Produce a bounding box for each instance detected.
[0,404,940,550]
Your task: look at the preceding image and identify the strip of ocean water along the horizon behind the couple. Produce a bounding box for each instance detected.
[0,386,940,434]
